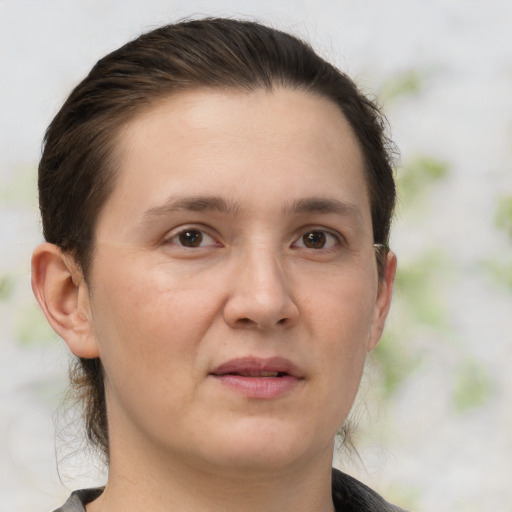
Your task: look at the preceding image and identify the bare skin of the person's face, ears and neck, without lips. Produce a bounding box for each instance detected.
[33,89,396,512]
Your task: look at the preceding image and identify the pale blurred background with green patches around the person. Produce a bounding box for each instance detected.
[0,0,512,512]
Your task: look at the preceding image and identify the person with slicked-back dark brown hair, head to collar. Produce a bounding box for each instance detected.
[32,19,399,512]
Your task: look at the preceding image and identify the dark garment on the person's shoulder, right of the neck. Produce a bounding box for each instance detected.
[332,468,405,512]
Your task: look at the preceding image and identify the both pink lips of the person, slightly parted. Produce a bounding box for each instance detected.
[210,357,304,399]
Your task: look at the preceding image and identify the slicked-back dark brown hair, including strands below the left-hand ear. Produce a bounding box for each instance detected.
[38,18,396,462]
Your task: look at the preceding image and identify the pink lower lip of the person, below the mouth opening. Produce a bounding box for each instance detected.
[213,375,300,399]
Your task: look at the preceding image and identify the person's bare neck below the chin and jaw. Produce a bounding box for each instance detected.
[87,440,334,512]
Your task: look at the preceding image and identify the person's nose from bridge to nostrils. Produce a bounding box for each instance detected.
[224,251,299,330]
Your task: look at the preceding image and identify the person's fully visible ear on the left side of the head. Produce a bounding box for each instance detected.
[32,243,99,358]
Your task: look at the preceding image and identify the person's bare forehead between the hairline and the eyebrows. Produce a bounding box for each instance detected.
[100,88,369,231]
